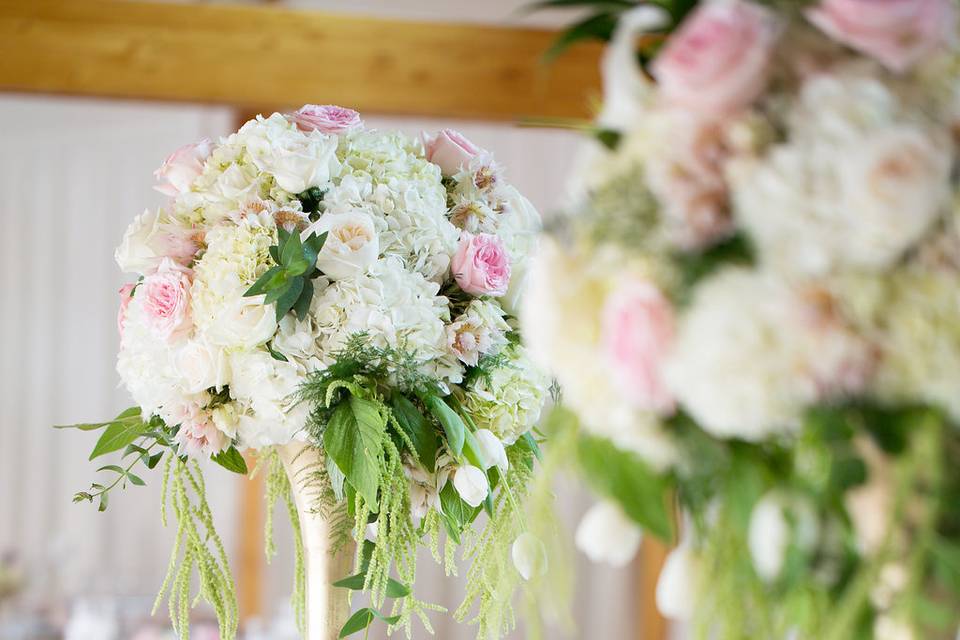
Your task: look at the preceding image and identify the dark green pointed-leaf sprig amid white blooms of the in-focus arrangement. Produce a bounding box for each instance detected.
[243,227,327,322]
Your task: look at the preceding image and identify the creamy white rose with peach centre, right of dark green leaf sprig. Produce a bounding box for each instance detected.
[302,211,380,280]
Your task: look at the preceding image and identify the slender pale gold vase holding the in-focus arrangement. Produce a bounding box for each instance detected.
[278,442,353,640]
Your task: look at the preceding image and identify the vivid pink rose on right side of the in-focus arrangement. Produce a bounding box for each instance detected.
[451,232,510,297]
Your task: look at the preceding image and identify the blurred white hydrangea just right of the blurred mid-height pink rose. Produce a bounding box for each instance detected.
[665,268,872,440]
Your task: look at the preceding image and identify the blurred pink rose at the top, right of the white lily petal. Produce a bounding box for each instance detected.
[651,0,780,115]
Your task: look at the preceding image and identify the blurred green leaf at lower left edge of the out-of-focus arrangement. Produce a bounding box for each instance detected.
[579,436,673,541]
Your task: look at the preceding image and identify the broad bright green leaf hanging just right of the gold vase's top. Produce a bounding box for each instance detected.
[323,396,386,512]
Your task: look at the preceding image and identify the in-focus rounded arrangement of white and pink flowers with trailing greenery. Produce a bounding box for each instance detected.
[62,105,548,638]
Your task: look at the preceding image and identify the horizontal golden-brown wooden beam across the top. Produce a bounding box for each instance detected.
[0,0,600,120]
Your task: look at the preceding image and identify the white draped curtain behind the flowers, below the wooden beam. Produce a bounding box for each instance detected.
[0,96,636,640]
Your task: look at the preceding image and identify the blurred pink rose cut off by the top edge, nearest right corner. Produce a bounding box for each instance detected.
[806,0,956,73]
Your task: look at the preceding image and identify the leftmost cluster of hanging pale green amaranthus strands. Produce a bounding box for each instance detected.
[153,455,239,640]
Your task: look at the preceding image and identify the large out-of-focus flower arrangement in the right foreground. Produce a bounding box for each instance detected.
[523,0,960,640]
